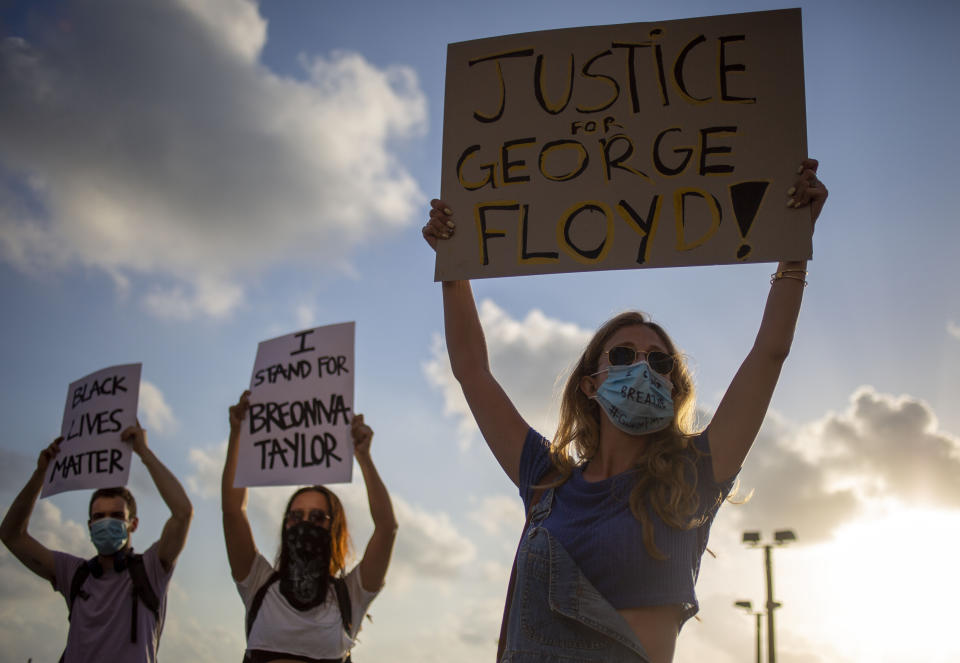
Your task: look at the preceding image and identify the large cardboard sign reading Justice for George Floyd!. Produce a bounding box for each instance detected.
[435,9,813,280]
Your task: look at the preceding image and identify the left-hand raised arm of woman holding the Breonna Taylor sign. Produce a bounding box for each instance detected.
[220,391,257,582]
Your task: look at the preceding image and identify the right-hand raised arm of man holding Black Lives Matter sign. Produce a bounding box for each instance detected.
[120,422,193,571]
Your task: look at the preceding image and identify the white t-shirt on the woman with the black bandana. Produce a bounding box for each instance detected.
[237,553,379,658]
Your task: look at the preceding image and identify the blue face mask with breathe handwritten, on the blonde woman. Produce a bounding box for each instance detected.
[593,361,673,435]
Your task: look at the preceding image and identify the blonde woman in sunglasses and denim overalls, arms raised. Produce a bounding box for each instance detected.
[422,159,827,663]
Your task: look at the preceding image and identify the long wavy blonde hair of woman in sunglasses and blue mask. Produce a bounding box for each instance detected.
[544,311,699,559]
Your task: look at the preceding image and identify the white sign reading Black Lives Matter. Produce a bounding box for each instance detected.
[40,364,141,497]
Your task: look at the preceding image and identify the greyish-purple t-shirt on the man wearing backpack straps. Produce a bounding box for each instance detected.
[53,543,173,663]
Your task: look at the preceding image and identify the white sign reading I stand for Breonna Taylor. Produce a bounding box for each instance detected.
[234,322,354,487]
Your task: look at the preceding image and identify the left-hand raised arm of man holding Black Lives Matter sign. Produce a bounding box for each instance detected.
[0,437,63,582]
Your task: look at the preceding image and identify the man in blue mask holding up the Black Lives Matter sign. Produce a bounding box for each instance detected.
[0,424,193,663]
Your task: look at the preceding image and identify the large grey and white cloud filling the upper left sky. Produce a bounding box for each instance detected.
[0,0,426,319]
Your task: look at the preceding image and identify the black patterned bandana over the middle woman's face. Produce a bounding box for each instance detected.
[280,521,333,610]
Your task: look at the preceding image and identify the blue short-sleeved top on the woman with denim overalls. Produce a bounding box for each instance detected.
[520,428,734,621]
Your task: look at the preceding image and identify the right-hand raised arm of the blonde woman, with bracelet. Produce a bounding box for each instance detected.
[709,159,827,480]
